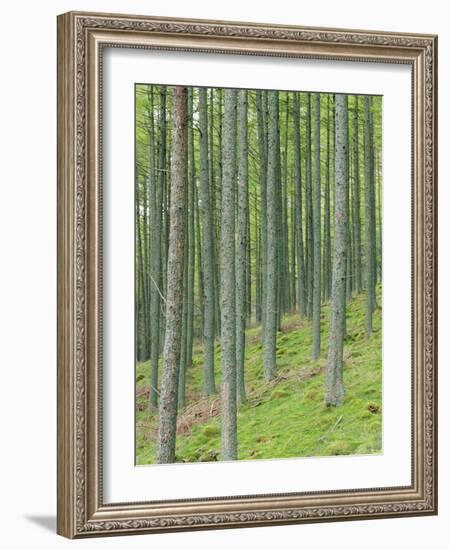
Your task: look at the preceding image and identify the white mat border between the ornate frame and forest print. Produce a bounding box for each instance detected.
[103,48,411,502]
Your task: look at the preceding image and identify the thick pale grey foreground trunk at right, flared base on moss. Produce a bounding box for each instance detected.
[325,94,348,406]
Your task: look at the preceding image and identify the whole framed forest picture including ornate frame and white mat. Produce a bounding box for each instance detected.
[58,12,437,538]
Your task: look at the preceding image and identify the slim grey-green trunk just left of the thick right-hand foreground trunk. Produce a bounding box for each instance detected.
[312,94,321,360]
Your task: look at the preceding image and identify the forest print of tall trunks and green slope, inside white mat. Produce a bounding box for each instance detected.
[134,84,383,465]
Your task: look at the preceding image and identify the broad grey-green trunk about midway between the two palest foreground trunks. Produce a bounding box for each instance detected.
[264,91,279,381]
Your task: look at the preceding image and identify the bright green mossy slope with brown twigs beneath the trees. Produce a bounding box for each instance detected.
[136,287,382,464]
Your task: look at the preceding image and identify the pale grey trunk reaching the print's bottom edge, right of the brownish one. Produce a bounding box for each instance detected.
[220,89,237,460]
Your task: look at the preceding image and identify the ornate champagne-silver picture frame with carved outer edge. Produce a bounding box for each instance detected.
[57,12,437,538]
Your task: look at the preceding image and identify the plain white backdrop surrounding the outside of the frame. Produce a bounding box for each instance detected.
[0,0,442,550]
